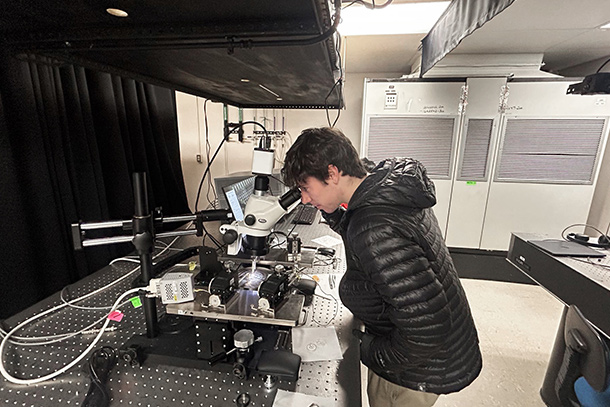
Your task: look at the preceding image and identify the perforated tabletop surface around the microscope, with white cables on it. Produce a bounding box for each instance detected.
[0,214,361,407]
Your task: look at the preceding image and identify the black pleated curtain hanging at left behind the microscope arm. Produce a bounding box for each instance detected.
[0,50,189,318]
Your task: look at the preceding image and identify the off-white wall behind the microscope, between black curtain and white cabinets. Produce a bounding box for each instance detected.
[176,72,401,210]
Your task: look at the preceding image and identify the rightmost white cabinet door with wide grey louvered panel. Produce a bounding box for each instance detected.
[481,116,607,250]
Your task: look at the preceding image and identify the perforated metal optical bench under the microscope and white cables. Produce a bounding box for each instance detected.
[0,214,361,407]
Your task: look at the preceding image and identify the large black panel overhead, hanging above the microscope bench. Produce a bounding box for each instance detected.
[0,0,342,108]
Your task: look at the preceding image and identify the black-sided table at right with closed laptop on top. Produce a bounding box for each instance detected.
[507,233,610,338]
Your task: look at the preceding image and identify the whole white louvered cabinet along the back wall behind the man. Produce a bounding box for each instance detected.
[361,78,610,250]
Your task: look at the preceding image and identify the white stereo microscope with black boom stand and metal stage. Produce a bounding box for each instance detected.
[72,158,305,388]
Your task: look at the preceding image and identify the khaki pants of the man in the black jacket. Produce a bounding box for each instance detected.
[367,369,438,407]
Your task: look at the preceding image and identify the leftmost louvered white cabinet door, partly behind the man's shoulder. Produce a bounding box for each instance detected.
[360,81,464,236]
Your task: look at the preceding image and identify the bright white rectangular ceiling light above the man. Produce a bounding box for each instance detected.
[338,1,450,36]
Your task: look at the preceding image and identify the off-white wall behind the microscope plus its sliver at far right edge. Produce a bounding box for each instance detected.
[176,73,610,245]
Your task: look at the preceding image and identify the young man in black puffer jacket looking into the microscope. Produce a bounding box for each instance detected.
[282,128,482,407]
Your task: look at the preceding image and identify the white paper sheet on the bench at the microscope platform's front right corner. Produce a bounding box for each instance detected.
[292,326,343,362]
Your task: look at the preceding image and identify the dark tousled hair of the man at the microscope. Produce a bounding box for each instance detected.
[282,127,366,188]
